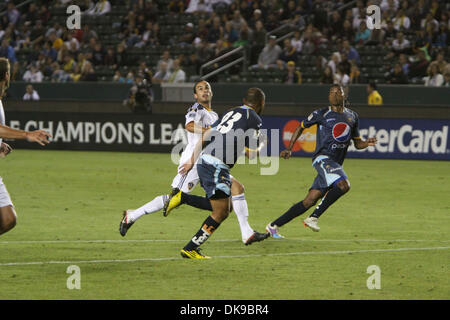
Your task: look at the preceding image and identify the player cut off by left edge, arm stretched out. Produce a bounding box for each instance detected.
[0,58,50,234]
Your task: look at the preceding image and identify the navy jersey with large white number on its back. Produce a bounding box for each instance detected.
[203,105,262,168]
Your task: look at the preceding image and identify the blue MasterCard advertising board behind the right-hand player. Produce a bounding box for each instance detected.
[263,117,450,160]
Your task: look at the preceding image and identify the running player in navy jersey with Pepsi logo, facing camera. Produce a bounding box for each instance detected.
[266,85,377,238]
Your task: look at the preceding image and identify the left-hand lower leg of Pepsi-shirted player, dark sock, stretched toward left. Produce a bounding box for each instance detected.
[266,189,323,239]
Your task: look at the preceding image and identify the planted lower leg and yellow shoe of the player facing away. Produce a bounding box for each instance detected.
[181,197,231,259]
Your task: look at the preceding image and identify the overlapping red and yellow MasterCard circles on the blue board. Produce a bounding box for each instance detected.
[283,120,317,153]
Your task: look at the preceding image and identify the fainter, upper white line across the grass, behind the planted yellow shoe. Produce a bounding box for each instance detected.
[0,238,450,245]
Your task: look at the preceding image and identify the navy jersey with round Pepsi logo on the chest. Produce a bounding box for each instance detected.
[301,107,360,165]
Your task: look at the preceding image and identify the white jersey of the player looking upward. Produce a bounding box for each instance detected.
[180,103,219,165]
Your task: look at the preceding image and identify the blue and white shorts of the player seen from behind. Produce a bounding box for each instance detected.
[197,154,232,199]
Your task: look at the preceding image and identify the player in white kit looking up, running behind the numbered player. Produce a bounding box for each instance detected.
[119,80,267,245]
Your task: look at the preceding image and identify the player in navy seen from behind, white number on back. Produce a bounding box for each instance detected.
[180,88,265,259]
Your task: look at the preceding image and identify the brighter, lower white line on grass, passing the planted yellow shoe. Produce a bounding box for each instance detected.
[0,247,450,267]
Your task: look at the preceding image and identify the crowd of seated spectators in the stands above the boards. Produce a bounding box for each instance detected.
[0,0,450,90]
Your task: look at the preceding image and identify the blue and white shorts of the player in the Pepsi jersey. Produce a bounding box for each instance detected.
[310,156,348,192]
